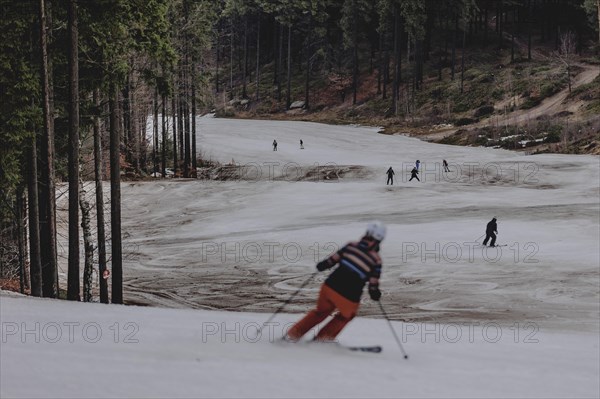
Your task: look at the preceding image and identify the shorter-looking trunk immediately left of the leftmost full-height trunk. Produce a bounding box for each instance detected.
[27,132,42,297]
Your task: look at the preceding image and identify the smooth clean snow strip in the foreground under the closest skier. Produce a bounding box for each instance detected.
[0,295,600,398]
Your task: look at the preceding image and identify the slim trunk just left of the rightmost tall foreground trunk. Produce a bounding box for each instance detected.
[94,89,108,303]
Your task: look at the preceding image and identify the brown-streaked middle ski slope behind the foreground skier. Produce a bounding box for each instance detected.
[54,117,600,332]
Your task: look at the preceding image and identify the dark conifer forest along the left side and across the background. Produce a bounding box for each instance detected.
[0,0,600,303]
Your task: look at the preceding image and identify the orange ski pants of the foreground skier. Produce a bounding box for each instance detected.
[288,284,359,341]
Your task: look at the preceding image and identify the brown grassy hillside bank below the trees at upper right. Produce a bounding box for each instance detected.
[215,35,600,154]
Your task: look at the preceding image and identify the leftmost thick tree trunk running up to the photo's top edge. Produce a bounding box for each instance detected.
[39,0,58,298]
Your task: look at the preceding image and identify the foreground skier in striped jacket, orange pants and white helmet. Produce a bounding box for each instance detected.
[286,222,386,341]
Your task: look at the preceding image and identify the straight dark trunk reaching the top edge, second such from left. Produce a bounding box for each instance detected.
[67,0,81,301]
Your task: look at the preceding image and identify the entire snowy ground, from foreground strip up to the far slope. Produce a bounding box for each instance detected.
[0,117,600,397]
